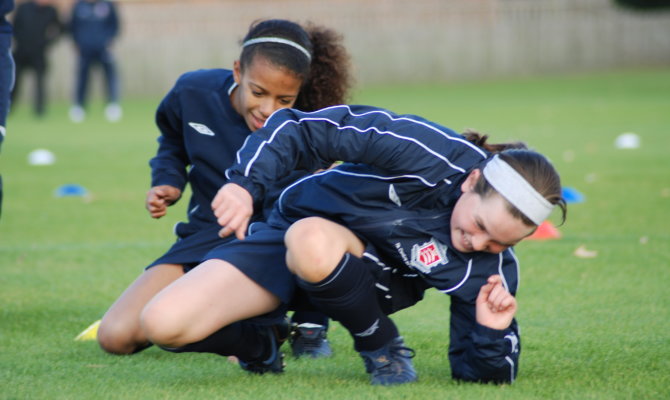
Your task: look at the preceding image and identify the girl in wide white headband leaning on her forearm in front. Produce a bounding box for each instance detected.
[142,105,566,385]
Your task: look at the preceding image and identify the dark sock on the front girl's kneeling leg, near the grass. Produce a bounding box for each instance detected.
[161,321,271,361]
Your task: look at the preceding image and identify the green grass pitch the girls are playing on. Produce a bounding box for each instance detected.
[0,70,670,400]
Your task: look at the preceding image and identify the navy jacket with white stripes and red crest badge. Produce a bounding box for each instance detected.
[226,105,520,382]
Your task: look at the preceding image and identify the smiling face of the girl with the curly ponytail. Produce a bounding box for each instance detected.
[230,55,302,132]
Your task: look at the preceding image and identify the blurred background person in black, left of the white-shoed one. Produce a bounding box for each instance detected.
[12,0,63,117]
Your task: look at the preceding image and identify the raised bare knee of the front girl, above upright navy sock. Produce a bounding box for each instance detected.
[284,217,363,282]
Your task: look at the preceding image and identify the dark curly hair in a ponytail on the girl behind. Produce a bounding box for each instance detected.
[240,19,352,111]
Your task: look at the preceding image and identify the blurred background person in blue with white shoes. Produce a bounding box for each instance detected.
[70,0,122,123]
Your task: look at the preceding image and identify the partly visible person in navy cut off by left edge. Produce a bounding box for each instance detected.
[0,0,14,219]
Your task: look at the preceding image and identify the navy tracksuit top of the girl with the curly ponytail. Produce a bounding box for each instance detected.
[150,68,307,230]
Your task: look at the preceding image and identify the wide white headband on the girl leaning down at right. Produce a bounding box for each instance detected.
[483,155,554,225]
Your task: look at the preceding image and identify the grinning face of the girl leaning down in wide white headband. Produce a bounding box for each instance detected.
[451,169,536,254]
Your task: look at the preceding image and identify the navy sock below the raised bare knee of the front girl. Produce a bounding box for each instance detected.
[298,254,398,351]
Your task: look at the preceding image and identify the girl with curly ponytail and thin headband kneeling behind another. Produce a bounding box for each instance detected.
[98,19,351,356]
